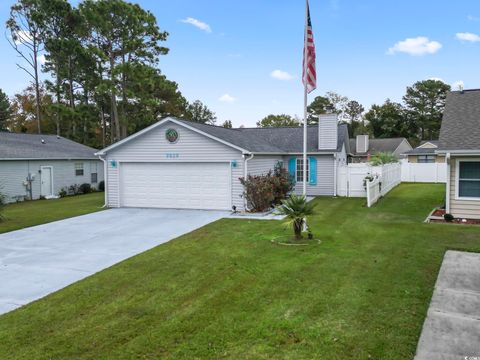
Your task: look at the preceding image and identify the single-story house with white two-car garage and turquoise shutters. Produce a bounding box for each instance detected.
[97,114,349,210]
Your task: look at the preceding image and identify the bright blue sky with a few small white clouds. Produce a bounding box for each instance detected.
[0,0,480,126]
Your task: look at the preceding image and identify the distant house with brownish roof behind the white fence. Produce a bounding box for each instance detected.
[349,135,412,163]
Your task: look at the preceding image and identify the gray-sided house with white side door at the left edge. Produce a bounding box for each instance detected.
[0,132,103,202]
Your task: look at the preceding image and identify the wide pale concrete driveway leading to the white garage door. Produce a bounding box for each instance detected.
[0,209,229,314]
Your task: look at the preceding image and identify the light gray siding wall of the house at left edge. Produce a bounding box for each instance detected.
[0,160,103,202]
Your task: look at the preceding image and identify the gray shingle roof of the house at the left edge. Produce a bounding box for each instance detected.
[0,132,97,160]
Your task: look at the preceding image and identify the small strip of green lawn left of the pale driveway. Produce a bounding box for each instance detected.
[0,192,103,235]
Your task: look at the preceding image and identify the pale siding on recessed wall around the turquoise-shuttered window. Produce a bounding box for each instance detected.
[283,155,335,196]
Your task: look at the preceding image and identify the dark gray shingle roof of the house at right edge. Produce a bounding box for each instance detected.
[438,89,480,152]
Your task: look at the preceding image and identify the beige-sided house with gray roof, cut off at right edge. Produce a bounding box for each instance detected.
[436,89,480,219]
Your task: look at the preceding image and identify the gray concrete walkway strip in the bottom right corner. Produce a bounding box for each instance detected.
[415,251,480,360]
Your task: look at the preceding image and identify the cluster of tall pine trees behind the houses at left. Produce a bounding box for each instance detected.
[0,0,216,147]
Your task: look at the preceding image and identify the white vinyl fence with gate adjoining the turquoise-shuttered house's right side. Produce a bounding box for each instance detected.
[337,163,402,206]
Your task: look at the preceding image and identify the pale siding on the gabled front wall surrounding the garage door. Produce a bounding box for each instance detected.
[101,122,244,209]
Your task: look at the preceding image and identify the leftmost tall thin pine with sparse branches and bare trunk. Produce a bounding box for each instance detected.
[7,0,45,134]
